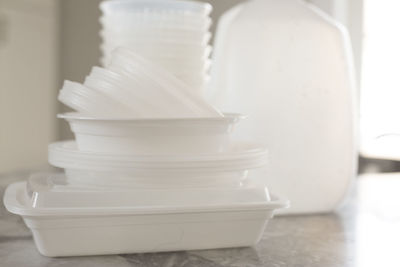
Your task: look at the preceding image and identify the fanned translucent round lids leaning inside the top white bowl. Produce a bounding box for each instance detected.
[59,47,222,118]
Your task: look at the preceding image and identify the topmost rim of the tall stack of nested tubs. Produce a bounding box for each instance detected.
[100,0,212,16]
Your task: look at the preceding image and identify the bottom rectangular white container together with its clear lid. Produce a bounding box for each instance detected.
[4,175,288,257]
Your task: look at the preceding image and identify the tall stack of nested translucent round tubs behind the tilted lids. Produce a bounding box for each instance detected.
[100,0,212,92]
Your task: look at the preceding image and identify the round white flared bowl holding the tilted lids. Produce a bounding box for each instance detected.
[58,113,243,154]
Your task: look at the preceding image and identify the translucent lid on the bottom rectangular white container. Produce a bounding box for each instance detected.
[26,174,271,209]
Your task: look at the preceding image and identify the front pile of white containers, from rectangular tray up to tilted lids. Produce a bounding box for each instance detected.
[4,0,288,256]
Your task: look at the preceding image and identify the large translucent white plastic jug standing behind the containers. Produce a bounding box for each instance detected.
[209,0,357,213]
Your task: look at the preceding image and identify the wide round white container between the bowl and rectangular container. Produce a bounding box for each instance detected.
[49,141,268,189]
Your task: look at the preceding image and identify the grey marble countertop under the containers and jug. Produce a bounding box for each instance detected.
[0,174,400,267]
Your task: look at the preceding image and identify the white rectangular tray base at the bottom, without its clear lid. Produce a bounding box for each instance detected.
[4,178,288,257]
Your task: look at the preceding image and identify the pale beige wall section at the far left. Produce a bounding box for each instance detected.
[0,0,58,173]
